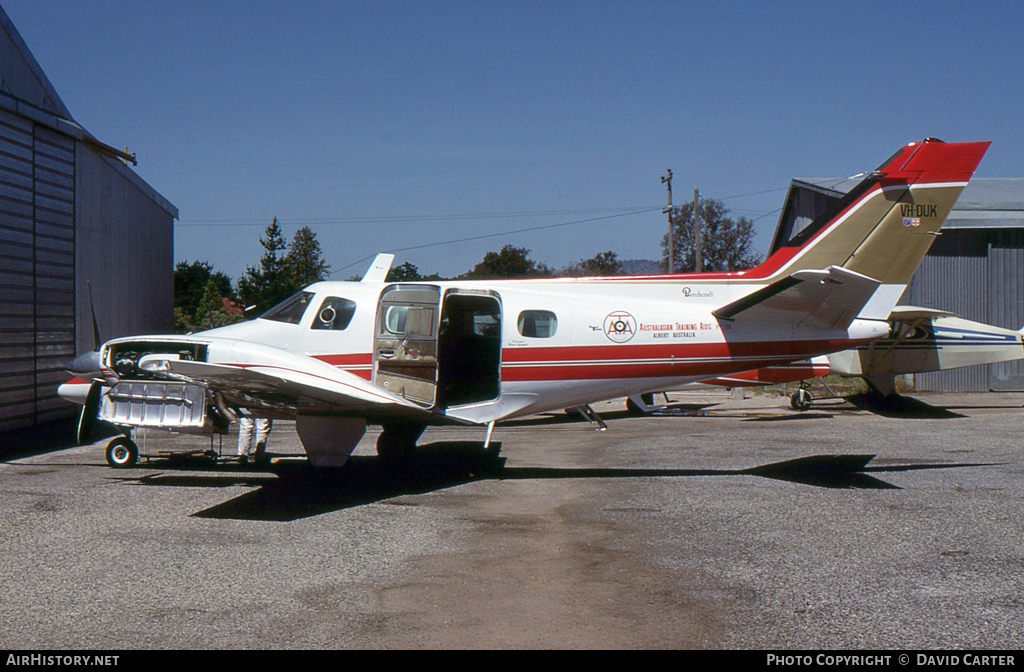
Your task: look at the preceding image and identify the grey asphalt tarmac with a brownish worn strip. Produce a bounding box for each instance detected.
[0,392,1024,650]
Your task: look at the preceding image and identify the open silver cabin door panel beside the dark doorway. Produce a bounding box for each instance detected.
[374,285,440,408]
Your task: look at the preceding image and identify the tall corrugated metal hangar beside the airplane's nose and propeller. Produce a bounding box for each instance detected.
[0,8,178,433]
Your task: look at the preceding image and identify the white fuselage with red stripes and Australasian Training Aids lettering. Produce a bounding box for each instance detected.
[186,279,888,423]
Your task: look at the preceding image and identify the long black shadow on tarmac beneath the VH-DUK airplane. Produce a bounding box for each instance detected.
[110,442,984,521]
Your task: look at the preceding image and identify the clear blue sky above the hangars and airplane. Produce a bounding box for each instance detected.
[0,0,1024,280]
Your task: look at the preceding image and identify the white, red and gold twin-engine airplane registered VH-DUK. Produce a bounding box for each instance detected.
[61,139,989,466]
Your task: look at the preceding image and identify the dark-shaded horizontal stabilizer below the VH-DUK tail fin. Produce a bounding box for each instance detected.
[713,266,879,330]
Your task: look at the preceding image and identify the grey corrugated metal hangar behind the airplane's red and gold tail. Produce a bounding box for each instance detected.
[771,177,1024,391]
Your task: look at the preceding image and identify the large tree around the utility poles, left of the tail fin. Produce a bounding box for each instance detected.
[662,199,761,272]
